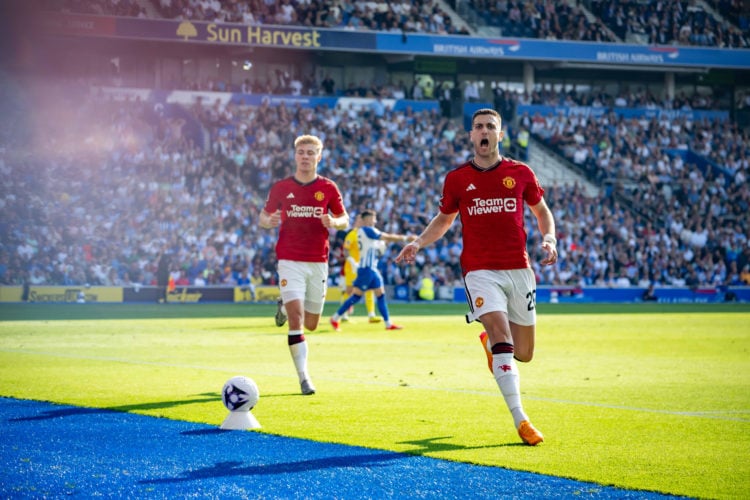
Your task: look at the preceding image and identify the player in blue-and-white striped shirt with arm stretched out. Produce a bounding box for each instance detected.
[331,210,416,332]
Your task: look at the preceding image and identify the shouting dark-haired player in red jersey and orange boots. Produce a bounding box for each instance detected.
[396,109,557,446]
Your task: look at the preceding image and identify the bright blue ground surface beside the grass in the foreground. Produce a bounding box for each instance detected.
[0,398,680,499]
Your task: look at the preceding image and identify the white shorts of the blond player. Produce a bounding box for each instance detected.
[278,260,328,314]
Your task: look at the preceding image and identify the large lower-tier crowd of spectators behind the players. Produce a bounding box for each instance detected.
[0,74,750,294]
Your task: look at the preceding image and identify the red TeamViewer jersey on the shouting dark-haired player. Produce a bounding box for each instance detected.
[440,158,544,274]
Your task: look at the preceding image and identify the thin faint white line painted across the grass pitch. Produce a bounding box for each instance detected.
[5,348,750,422]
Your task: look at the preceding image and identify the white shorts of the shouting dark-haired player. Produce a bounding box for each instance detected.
[464,269,536,326]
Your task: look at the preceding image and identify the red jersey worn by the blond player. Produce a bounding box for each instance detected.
[263,176,346,262]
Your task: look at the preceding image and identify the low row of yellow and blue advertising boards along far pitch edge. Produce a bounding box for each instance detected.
[0,285,750,304]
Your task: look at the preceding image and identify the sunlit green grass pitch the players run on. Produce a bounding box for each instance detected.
[0,304,750,498]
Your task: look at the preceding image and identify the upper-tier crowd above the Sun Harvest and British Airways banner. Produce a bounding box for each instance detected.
[42,0,750,48]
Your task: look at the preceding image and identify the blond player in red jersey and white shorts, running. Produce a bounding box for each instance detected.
[260,135,349,395]
